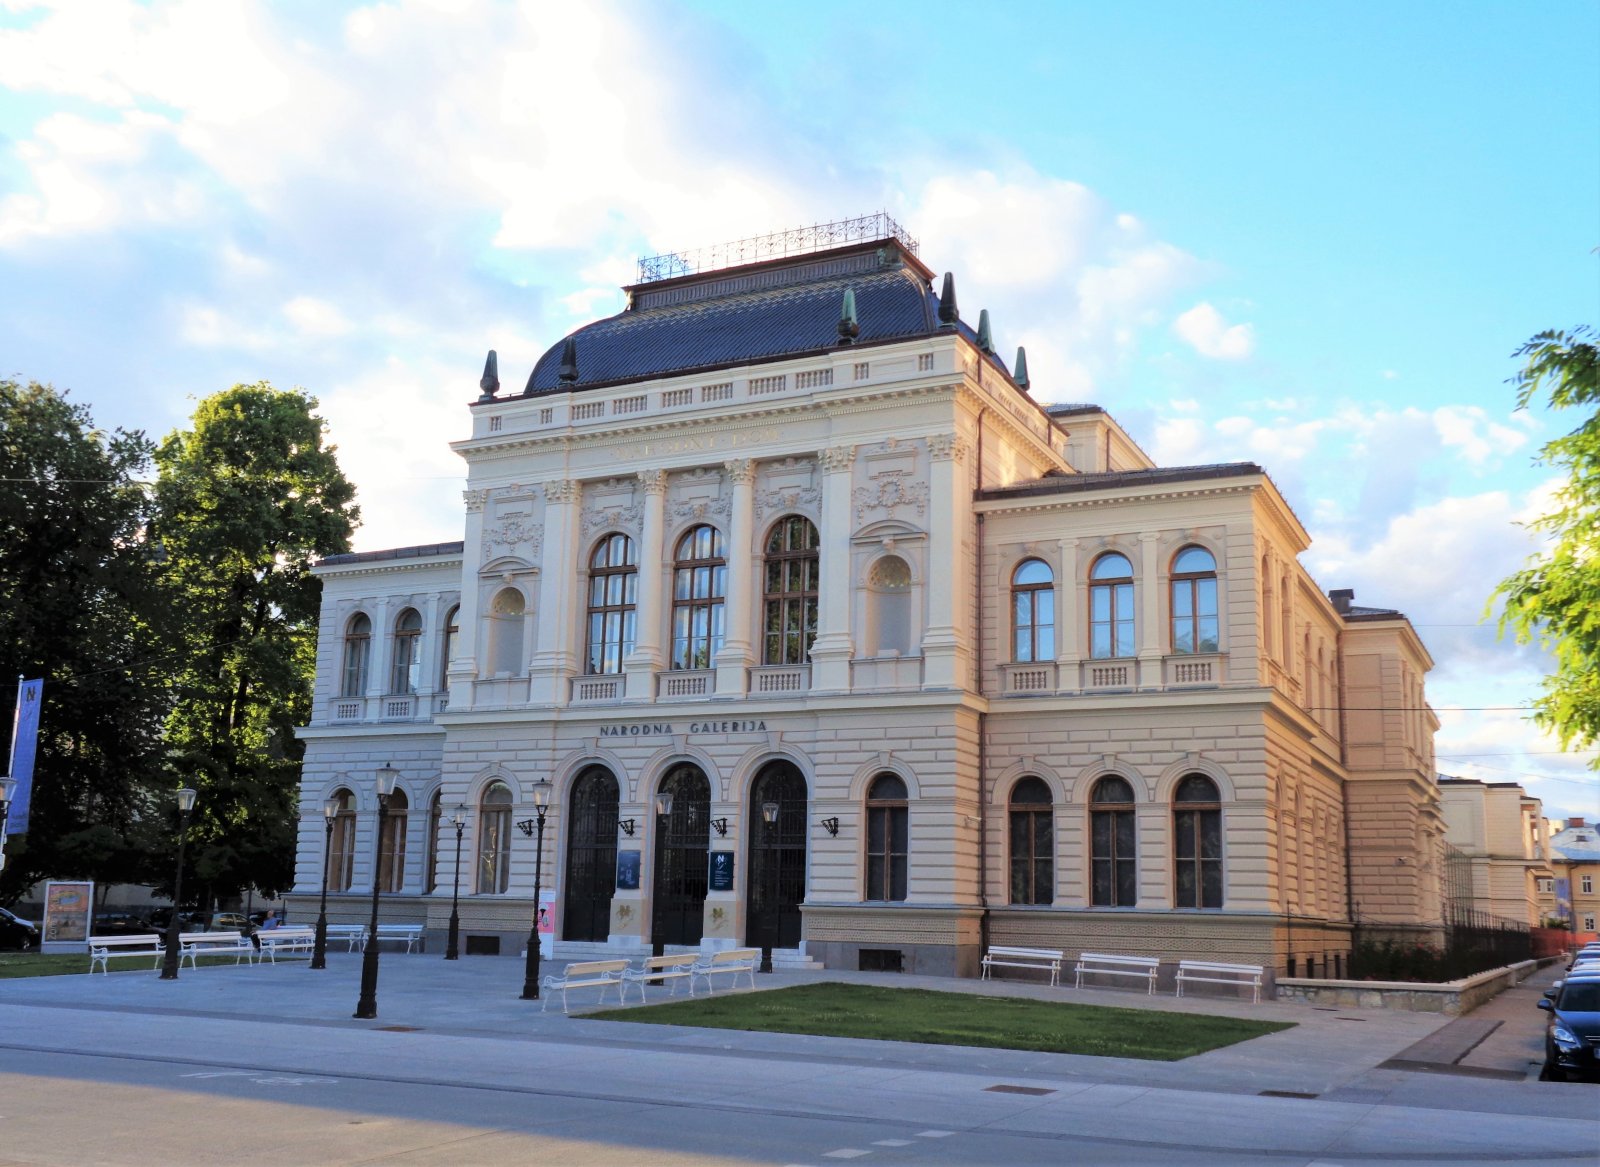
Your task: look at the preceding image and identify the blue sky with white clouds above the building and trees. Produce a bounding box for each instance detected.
[0,0,1600,815]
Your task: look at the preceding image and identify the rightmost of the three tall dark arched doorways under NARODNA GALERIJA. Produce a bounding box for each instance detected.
[744,762,806,948]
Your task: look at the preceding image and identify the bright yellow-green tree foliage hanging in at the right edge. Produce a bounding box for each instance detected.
[1491,327,1600,749]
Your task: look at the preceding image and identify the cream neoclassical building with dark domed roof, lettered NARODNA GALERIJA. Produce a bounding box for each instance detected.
[294,216,1443,975]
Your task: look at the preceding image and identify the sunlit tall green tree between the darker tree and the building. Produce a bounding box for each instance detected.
[154,381,358,895]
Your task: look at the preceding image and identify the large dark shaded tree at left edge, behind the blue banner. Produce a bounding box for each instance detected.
[0,379,174,903]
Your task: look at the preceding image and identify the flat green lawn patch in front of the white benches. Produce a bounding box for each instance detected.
[584,983,1291,1061]
